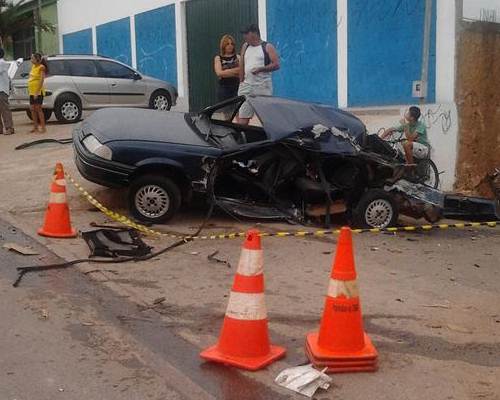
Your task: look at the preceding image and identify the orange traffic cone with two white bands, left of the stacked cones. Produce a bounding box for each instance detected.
[200,230,285,371]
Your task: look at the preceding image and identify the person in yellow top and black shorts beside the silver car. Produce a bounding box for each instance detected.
[28,53,48,133]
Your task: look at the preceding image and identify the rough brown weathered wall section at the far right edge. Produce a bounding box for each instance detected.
[456,22,500,196]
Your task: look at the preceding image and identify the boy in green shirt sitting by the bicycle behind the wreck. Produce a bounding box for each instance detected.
[381,106,430,164]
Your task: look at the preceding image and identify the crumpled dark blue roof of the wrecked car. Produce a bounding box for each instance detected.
[247,96,366,144]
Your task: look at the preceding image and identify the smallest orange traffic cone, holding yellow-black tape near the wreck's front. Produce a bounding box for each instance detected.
[38,163,76,238]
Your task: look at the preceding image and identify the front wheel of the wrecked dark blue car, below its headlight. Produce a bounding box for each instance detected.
[128,175,182,224]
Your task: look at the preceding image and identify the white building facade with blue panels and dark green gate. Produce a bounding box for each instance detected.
[58,0,455,109]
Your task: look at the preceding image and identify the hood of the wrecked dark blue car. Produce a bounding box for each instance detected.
[82,108,210,147]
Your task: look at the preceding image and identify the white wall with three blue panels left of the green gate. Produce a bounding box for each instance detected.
[58,0,182,94]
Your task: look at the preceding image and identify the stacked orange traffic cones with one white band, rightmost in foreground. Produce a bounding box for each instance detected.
[306,227,377,372]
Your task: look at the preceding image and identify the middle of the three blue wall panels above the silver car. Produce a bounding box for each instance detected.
[96,18,132,65]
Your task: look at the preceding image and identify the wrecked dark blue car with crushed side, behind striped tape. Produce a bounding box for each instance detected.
[73,96,438,228]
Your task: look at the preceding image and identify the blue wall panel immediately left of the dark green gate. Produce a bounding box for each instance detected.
[135,4,177,85]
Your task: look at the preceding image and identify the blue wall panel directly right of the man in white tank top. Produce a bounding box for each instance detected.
[267,0,337,105]
